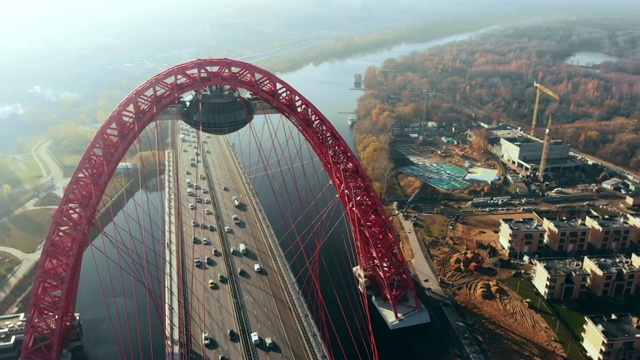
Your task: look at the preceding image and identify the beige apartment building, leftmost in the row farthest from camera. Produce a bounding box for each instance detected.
[498,216,546,253]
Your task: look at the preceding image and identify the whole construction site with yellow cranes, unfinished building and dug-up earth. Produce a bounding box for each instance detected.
[392,83,640,359]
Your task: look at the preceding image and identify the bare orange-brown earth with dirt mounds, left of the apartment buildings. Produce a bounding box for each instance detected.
[427,214,565,359]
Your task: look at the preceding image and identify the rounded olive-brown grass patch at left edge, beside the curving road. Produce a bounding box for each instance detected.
[0,209,51,253]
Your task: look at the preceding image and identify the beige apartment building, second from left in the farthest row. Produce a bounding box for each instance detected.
[542,218,591,252]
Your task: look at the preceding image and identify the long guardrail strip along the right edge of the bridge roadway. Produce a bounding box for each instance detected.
[225,138,329,359]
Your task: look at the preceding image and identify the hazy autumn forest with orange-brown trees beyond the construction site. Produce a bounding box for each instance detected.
[357,18,640,173]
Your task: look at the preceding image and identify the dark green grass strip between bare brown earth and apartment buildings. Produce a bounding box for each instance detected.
[500,278,585,360]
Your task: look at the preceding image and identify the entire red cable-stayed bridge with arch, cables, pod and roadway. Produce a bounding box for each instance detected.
[11,59,429,359]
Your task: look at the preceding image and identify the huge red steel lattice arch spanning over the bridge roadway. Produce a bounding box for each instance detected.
[22,59,419,359]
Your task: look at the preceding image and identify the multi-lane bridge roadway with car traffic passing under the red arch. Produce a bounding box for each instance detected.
[176,127,310,359]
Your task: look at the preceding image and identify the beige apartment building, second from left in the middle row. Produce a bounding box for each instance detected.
[583,254,640,298]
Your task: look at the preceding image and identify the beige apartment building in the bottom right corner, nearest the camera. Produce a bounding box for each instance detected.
[582,314,640,360]
